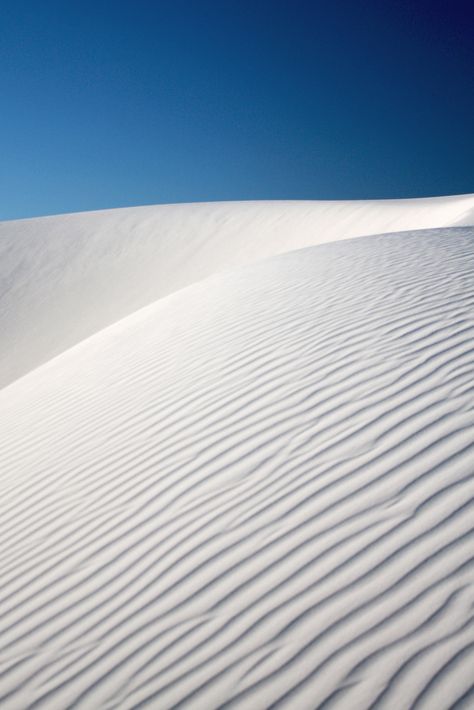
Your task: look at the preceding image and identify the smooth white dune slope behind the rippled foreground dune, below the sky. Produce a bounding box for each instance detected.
[0,195,474,386]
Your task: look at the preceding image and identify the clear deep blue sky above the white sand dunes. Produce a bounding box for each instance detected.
[0,0,474,219]
